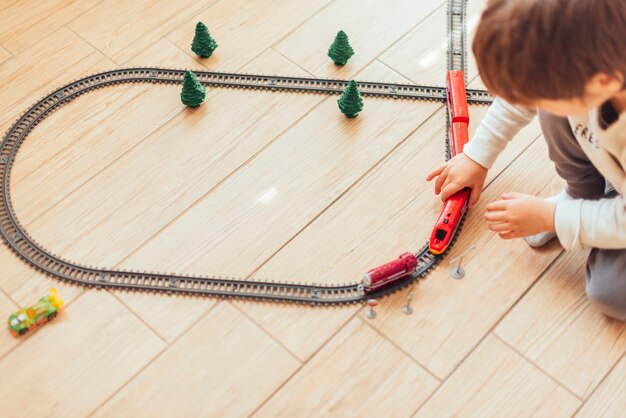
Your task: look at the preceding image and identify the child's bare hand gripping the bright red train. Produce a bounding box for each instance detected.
[426,154,488,208]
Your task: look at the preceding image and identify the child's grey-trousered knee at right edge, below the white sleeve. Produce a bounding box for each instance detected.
[586,268,626,321]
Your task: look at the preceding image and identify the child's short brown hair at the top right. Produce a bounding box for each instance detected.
[473,0,626,104]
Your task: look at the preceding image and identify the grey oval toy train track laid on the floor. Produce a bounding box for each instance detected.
[0,0,491,305]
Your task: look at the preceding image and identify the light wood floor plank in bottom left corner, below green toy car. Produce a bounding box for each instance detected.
[0,291,164,417]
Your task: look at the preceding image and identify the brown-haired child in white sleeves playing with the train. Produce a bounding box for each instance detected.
[427,0,626,321]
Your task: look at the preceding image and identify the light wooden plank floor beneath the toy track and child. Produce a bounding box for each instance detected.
[0,0,626,417]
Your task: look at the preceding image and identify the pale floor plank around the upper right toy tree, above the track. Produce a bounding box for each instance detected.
[276,0,443,78]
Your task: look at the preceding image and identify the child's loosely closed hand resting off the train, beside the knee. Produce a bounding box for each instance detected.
[485,193,556,239]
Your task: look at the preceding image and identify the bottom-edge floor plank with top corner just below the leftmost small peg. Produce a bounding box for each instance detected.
[254,318,438,417]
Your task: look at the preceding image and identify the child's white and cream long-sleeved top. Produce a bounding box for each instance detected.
[463,98,626,250]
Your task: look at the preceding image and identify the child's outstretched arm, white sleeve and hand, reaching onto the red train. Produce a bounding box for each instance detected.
[426,98,536,207]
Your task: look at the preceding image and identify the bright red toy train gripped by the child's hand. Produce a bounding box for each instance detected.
[429,70,470,254]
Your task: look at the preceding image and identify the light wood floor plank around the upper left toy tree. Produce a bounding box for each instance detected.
[167,0,330,74]
